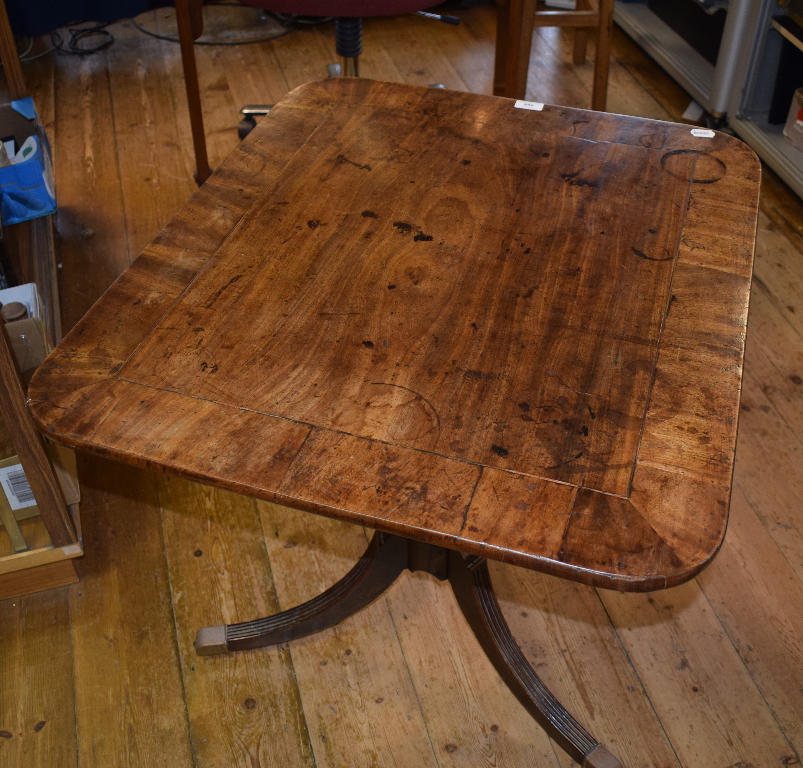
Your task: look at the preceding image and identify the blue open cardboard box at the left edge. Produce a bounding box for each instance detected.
[0,98,56,225]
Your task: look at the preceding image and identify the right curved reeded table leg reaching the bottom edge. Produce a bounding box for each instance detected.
[449,552,622,768]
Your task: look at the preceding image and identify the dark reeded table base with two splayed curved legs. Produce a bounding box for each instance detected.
[195,532,622,768]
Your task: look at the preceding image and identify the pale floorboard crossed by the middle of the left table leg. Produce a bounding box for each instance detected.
[258,503,439,768]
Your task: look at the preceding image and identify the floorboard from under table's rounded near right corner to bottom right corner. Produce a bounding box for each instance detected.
[600,582,797,768]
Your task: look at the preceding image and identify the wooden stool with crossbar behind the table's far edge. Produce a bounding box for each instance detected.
[494,0,613,111]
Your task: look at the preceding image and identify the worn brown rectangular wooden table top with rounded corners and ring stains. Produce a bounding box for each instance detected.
[29,79,760,590]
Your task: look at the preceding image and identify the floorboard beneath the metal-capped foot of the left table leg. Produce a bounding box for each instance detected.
[158,477,313,768]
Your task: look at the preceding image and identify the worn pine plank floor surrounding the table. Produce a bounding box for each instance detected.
[0,4,803,768]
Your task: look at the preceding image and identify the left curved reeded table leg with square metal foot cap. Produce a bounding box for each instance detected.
[195,533,409,656]
